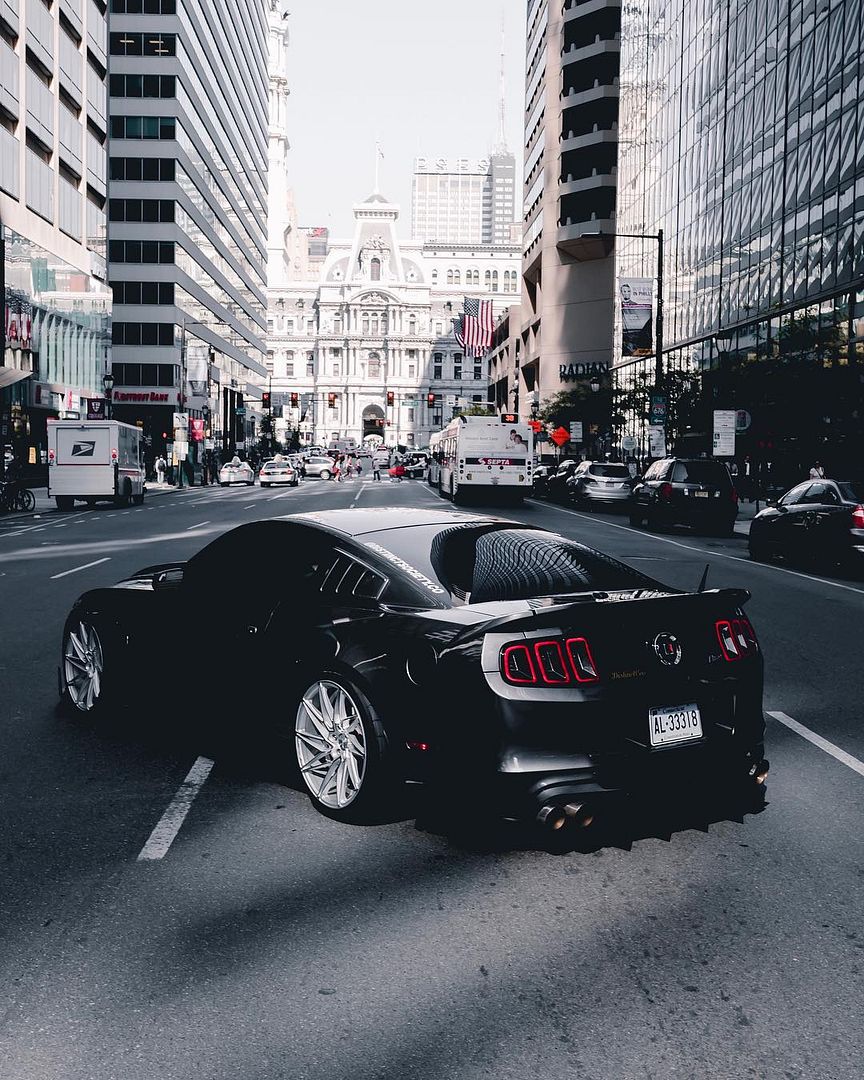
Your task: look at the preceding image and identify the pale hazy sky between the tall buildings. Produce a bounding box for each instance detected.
[285,0,525,239]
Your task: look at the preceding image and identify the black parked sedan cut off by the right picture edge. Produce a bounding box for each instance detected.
[747,480,864,566]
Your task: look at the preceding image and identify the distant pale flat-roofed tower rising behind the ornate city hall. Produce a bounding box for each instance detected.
[411,154,516,244]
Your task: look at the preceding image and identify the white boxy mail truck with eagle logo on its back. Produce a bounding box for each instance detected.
[48,420,145,510]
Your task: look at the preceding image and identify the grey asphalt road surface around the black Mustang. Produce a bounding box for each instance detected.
[0,482,864,1080]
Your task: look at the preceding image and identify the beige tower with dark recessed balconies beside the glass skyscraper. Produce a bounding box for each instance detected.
[518,0,621,414]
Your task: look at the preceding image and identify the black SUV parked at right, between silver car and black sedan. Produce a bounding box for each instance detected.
[630,458,738,536]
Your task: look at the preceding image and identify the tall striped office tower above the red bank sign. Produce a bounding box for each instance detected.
[109,0,270,459]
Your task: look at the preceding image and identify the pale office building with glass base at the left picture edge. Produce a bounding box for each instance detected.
[0,0,111,472]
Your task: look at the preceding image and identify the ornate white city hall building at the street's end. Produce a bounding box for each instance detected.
[267,192,521,447]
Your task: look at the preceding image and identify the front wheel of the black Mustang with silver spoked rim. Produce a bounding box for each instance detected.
[59,615,113,718]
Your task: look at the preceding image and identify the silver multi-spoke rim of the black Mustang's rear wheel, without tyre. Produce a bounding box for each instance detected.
[294,679,366,810]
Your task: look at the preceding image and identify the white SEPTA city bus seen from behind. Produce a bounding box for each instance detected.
[429,413,534,501]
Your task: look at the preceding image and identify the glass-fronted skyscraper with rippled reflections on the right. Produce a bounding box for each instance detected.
[616,0,864,482]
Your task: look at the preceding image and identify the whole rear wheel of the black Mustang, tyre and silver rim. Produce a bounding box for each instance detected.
[294,671,396,823]
